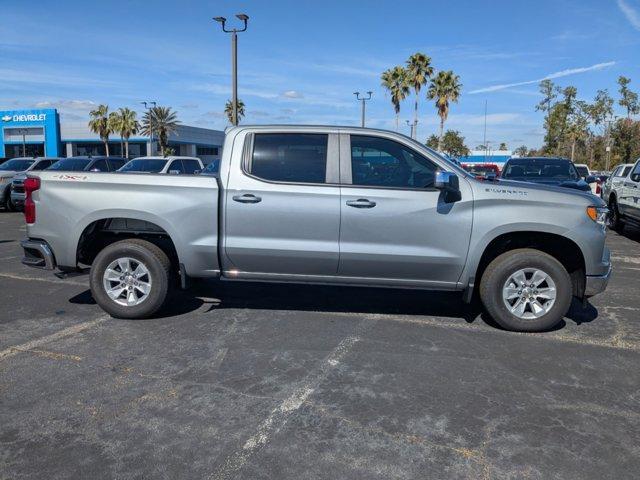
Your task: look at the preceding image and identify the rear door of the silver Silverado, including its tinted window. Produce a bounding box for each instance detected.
[224,131,340,278]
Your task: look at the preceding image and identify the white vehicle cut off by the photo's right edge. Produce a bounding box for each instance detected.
[608,158,640,232]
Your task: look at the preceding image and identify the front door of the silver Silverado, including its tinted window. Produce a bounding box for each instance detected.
[338,135,473,288]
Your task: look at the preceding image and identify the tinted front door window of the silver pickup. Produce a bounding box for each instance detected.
[351,135,438,188]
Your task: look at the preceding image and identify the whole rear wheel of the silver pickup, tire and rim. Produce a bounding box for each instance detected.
[90,239,171,318]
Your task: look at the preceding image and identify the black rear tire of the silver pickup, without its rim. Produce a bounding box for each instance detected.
[89,239,171,319]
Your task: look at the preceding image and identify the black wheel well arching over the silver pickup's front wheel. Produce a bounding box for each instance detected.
[475,232,585,297]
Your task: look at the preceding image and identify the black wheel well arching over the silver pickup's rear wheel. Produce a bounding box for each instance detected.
[76,218,179,268]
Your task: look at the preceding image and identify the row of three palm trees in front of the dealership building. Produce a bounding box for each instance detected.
[89,105,180,158]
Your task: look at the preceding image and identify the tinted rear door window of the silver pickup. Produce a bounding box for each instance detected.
[249,133,329,183]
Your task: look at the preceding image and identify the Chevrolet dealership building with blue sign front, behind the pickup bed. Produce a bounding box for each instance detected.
[0,109,224,164]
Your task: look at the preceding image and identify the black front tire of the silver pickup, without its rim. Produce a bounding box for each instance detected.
[480,248,573,332]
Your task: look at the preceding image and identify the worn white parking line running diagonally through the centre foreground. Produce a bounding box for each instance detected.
[210,320,375,480]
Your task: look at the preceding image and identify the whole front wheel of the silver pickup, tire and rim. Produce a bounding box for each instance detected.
[480,248,573,332]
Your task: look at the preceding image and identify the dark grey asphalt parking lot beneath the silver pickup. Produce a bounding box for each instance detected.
[0,212,640,479]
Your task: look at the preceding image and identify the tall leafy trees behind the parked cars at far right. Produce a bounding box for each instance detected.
[515,76,640,170]
